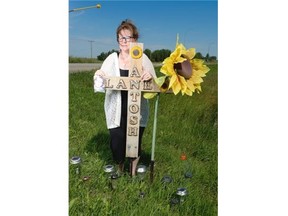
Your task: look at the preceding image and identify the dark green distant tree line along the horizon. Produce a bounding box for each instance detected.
[69,49,217,63]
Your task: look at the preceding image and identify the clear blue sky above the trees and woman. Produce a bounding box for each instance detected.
[69,0,218,57]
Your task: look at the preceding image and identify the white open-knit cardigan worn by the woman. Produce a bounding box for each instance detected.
[94,52,156,129]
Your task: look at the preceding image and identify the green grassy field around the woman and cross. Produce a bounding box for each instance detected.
[69,65,218,216]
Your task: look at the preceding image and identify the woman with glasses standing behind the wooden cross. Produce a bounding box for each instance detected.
[94,20,156,176]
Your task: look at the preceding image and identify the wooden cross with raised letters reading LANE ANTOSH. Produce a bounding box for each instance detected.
[105,43,160,158]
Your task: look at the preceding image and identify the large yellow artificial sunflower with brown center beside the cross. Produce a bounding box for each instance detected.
[144,35,210,99]
